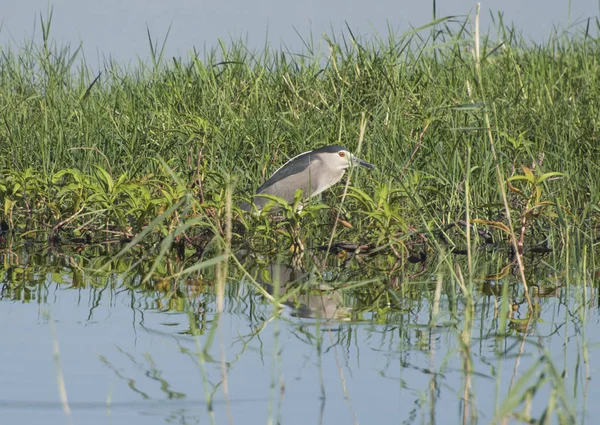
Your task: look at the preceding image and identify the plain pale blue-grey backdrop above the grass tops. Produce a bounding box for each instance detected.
[0,0,599,69]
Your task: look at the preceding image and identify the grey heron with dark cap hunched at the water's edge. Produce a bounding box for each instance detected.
[243,146,375,211]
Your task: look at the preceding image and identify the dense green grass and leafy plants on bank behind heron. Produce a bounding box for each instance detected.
[0,11,600,264]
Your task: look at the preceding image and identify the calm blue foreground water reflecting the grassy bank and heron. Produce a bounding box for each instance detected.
[0,248,600,425]
